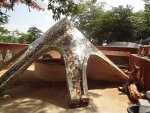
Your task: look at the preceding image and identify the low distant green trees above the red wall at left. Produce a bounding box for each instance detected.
[0,27,42,44]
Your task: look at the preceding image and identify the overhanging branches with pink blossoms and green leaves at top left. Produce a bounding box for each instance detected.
[0,0,78,22]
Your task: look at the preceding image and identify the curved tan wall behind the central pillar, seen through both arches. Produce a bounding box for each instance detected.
[34,55,125,82]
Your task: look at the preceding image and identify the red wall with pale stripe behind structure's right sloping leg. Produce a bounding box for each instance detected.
[97,46,138,69]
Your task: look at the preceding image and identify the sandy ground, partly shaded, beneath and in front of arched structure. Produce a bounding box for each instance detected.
[0,66,131,113]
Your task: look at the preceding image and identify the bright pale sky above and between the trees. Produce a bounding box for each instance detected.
[2,0,144,32]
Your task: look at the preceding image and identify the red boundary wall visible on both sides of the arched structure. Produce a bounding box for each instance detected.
[0,43,150,70]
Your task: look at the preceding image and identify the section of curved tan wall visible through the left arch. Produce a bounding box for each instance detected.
[34,61,66,82]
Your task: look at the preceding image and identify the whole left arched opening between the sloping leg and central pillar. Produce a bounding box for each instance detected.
[13,48,66,85]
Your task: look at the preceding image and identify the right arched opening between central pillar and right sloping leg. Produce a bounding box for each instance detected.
[86,55,118,89]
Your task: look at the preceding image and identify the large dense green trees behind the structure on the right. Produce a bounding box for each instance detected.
[71,1,150,45]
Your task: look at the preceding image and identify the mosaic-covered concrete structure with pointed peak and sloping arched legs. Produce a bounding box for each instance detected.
[0,18,128,105]
